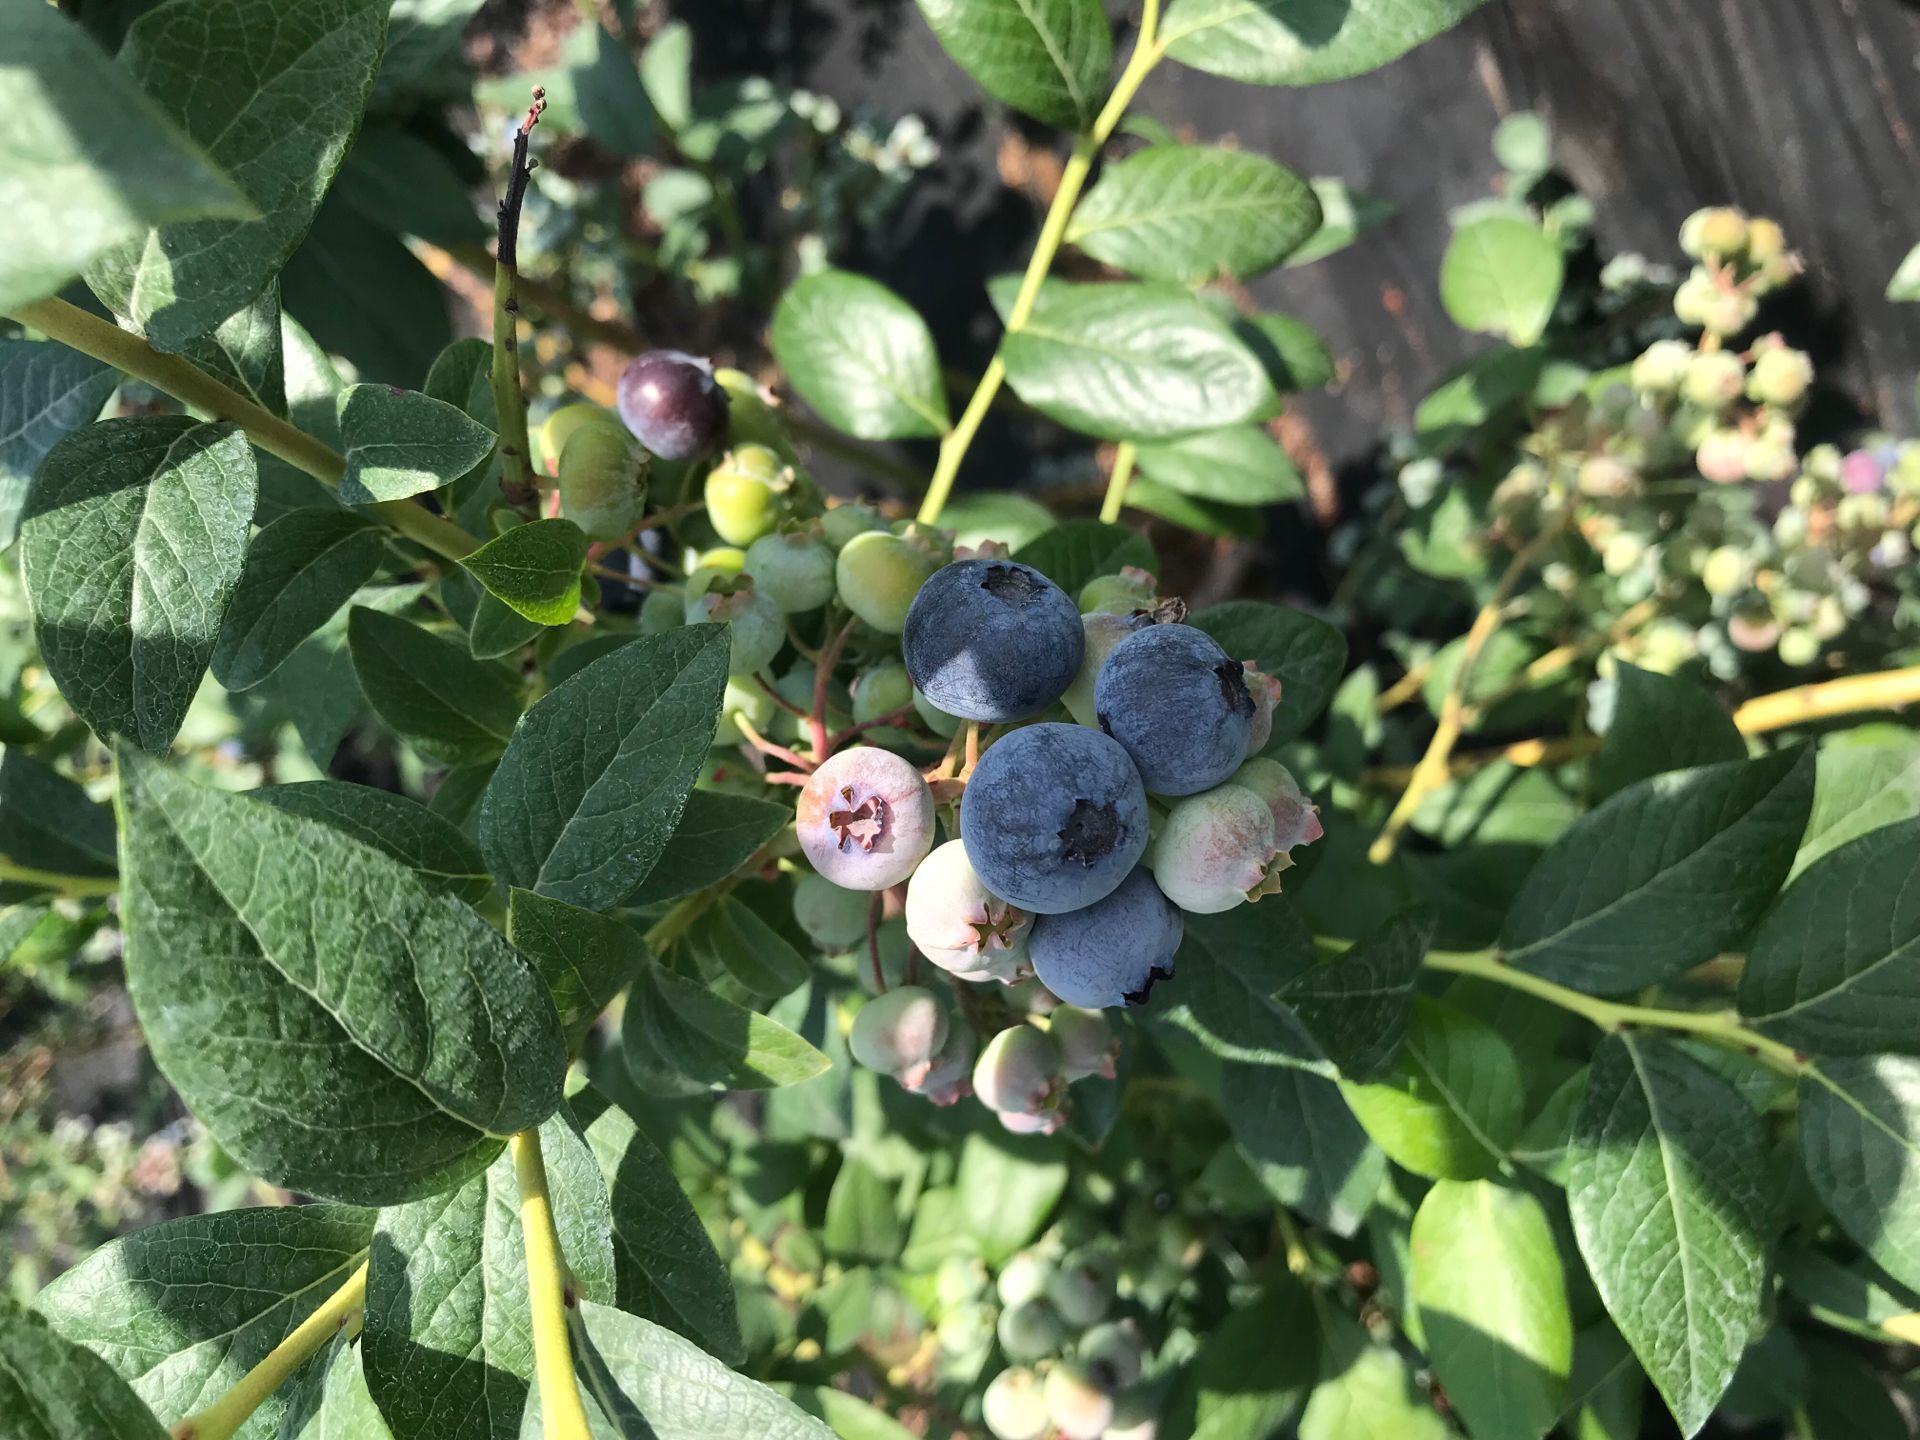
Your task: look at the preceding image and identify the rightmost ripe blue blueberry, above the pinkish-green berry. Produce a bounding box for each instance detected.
[1092,624,1256,795]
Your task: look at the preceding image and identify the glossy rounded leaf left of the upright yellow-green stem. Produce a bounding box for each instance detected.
[772,271,947,440]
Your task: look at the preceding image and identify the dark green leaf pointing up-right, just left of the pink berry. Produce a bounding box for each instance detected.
[480,626,728,910]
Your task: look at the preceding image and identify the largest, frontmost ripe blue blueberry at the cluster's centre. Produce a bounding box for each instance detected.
[960,724,1146,914]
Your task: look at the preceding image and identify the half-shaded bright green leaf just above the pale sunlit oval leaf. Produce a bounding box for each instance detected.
[1340,996,1524,1181]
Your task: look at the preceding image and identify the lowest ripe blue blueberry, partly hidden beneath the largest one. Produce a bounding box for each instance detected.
[1027,868,1183,1010]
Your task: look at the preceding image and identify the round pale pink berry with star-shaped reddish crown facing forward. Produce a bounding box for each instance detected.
[795,745,933,891]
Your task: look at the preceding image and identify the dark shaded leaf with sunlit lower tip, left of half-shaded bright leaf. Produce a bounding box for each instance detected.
[1221,1062,1386,1235]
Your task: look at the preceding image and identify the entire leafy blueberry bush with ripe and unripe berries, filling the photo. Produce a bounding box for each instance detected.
[0,0,1920,1440]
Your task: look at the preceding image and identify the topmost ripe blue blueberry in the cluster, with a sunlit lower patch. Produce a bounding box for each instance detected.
[900,561,1087,724]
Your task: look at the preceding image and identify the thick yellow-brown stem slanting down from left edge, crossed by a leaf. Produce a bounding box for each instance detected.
[8,300,480,561]
